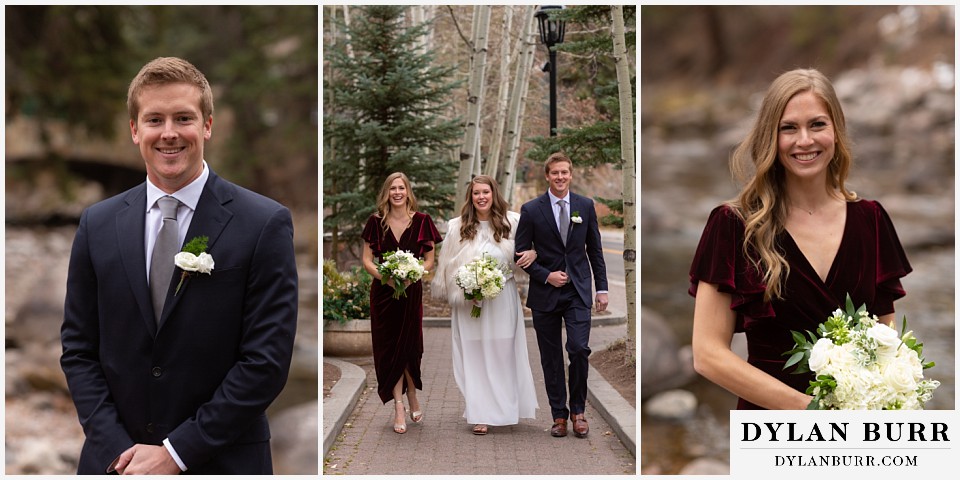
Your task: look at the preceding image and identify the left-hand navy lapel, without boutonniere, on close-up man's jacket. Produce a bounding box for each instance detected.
[116,183,157,334]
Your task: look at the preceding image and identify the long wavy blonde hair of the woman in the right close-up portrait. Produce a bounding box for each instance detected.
[727,69,857,302]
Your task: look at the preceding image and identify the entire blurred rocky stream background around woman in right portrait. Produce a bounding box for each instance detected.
[640,6,955,474]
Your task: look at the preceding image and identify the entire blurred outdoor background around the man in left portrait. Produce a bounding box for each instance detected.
[4,6,319,474]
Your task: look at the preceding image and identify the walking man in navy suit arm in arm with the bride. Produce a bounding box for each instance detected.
[516,152,608,438]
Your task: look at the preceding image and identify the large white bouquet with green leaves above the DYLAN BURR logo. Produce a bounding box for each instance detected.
[784,295,940,410]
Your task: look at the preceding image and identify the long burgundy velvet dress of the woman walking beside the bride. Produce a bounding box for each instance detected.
[361,212,443,403]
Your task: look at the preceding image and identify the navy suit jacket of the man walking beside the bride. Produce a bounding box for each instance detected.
[516,192,607,311]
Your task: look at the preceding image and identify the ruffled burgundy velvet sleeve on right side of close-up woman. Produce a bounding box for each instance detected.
[870,201,913,315]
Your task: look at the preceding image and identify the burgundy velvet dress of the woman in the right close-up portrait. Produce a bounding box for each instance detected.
[689,200,912,410]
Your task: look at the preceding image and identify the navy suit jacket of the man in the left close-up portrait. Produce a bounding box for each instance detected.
[60,171,298,474]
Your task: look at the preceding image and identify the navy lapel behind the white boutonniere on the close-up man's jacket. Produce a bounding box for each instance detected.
[160,170,233,328]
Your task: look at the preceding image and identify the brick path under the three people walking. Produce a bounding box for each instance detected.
[323,325,636,475]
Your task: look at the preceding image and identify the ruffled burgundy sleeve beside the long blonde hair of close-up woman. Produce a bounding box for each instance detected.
[688,205,775,331]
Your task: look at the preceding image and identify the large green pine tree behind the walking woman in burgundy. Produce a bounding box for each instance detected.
[323,5,463,256]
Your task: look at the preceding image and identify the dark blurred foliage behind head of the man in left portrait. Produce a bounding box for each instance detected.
[5,5,319,208]
